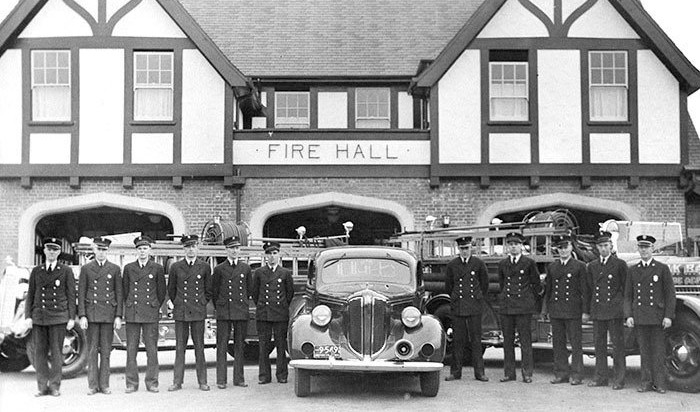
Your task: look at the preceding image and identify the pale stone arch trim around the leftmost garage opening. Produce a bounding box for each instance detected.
[17,193,188,265]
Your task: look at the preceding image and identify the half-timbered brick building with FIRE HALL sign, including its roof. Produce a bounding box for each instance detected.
[0,0,700,265]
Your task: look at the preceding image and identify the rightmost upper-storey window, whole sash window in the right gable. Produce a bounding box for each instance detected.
[588,51,628,121]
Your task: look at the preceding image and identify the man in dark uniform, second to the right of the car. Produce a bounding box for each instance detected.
[498,233,542,383]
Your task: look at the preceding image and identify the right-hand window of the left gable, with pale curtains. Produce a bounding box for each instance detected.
[134,52,173,120]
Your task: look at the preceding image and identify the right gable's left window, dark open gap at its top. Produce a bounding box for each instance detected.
[489,50,529,122]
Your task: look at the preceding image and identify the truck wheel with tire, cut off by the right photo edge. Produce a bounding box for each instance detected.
[665,311,700,392]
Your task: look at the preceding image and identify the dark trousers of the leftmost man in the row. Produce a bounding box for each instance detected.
[32,323,66,392]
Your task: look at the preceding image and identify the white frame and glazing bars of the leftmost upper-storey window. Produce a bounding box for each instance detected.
[31,50,72,122]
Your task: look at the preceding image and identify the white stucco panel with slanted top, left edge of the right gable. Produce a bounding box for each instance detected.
[438,50,481,163]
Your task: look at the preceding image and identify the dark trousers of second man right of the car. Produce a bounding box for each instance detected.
[501,313,533,379]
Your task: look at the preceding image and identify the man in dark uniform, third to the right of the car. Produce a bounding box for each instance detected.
[542,236,586,385]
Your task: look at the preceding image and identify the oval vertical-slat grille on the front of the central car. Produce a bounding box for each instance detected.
[345,290,390,357]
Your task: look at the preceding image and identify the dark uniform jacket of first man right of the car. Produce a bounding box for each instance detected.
[445,256,489,316]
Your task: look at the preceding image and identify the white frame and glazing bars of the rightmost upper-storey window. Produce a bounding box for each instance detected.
[588,50,629,122]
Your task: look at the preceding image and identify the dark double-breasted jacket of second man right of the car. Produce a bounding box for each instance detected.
[498,255,542,315]
